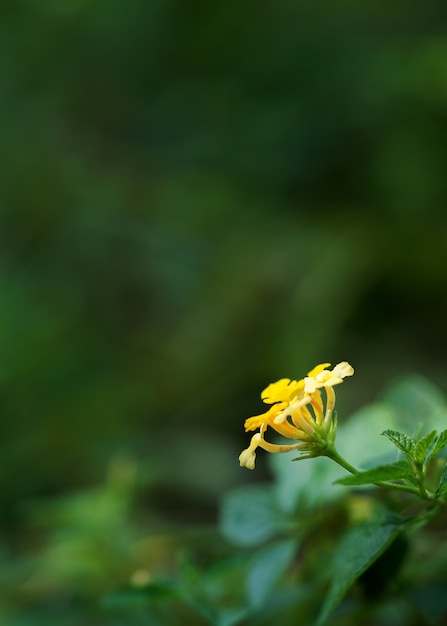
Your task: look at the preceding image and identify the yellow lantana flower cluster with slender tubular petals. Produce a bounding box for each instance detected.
[239,361,354,469]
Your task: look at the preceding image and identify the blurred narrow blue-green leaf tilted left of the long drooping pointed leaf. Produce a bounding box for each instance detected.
[247,539,297,609]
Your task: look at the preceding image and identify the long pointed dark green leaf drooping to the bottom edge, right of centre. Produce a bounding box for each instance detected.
[317,518,404,626]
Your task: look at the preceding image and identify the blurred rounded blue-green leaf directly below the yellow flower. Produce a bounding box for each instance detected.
[220,485,291,546]
